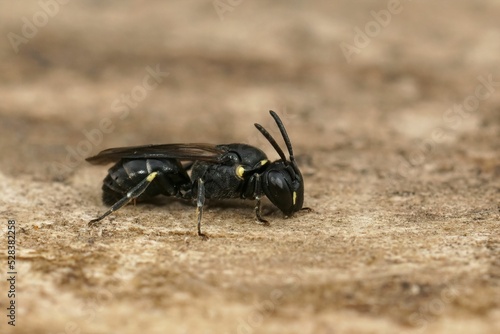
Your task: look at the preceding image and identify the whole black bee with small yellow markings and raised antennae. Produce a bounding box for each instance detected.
[87,110,304,236]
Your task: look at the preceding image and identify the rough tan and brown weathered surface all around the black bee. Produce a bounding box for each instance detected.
[0,0,500,334]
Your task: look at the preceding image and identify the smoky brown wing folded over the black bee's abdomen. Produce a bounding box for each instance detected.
[85,144,226,165]
